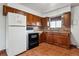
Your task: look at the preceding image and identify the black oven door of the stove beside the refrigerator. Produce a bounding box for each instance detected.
[28,33,39,49]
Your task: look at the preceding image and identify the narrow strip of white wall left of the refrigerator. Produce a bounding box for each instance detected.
[0,4,5,50]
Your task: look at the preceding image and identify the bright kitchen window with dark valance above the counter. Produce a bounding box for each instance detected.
[50,18,62,28]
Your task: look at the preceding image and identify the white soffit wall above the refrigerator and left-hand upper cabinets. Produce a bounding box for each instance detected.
[7,3,41,16]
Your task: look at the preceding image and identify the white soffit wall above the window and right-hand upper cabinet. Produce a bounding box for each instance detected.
[43,6,71,17]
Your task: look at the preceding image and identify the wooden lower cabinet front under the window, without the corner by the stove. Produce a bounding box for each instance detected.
[46,32,70,48]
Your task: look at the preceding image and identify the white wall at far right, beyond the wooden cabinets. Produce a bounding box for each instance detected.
[71,6,79,47]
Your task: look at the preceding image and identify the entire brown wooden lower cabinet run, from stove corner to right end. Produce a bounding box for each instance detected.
[40,32,70,48]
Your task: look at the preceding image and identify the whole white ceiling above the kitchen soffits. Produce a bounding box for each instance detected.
[22,3,79,13]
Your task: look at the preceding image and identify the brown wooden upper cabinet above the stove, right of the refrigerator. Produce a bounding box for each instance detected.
[27,13,41,26]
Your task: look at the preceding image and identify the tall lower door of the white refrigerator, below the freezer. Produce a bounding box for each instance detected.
[6,27,28,56]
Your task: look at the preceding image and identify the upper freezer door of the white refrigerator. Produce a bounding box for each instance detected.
[7,12,26,26]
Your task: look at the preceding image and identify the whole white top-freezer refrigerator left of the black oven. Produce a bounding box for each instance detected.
[6,12,28,56]
